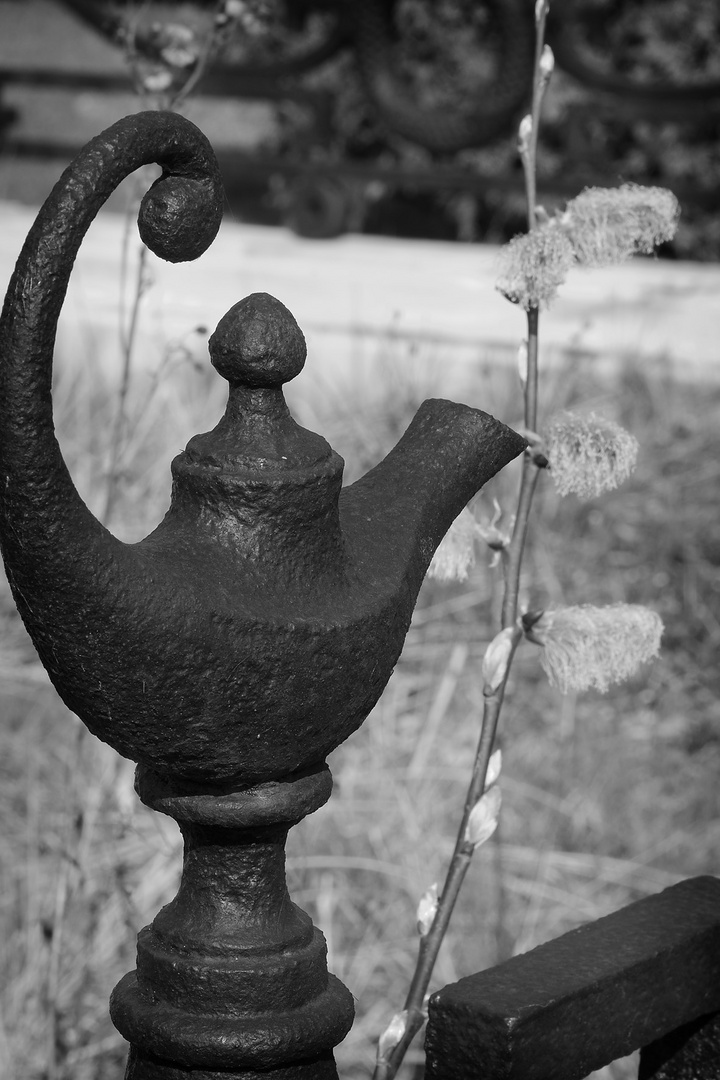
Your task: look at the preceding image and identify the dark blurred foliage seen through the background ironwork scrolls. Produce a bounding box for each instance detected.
[262,0,720,260]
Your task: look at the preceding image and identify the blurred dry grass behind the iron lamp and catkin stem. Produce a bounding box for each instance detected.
[0,291,720,1080]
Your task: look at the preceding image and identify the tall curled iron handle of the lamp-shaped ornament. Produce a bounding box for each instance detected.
[0,112,222,565]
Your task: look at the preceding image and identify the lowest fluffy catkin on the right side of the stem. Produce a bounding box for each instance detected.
[526,604,663,693]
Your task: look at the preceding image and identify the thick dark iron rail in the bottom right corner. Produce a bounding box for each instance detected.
[425,877,720,1080]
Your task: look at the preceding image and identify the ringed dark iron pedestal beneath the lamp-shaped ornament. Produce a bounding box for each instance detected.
[110,767,353,1080]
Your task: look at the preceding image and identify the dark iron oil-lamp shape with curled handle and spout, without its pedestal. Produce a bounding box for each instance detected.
[0,113,525,786]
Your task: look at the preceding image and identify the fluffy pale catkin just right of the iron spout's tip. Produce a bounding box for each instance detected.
[545,413,639,499]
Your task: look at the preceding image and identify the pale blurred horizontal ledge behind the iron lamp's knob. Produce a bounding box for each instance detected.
[0,202,720,396]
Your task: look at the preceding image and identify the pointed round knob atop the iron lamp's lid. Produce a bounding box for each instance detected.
[208,293,308,389]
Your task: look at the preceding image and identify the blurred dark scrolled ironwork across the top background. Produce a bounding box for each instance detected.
[0,0,720,251]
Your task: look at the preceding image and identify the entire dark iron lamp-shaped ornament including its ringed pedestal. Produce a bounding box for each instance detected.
[0,112,526,1080]
